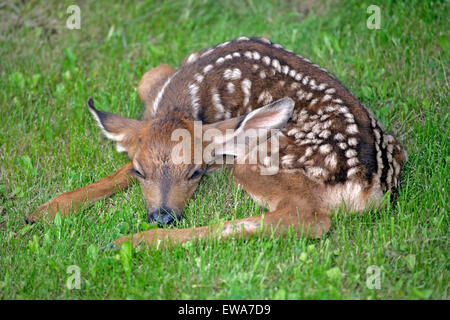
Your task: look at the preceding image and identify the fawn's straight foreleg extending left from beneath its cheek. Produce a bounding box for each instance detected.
[28,162,133,222]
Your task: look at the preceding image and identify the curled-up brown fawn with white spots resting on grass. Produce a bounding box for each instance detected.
[29,37,407,245]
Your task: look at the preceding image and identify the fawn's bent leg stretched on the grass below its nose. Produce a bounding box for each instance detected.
[115,165,331,246]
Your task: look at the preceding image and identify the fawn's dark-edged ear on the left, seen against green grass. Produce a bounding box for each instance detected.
[87,97,141,152]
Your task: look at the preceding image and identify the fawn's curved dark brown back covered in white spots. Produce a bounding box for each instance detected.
[144,37,406,199]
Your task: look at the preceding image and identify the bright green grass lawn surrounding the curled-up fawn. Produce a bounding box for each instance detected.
[0,0,450,299]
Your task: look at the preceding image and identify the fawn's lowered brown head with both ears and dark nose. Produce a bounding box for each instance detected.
[87,98,294,225]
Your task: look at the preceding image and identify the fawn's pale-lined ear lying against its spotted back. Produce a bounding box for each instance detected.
[205,98,295,158]
